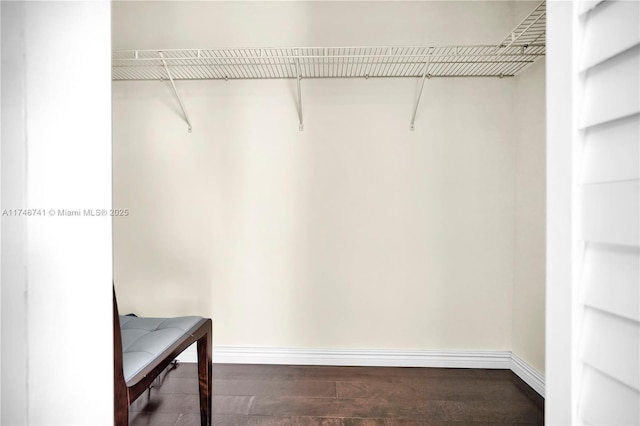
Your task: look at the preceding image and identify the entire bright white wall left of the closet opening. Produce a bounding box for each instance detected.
[0,1,113,425]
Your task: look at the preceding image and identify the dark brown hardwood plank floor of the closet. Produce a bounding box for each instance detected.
[129,363,544,426]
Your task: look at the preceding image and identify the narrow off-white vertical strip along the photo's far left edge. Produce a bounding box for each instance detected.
[0,2,27,424]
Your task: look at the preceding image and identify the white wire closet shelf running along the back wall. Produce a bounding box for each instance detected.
[112,2,546,80]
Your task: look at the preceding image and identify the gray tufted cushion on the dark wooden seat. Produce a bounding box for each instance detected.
[120,316,202,382]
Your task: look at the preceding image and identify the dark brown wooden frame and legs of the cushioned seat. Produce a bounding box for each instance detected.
[113,289,212,426]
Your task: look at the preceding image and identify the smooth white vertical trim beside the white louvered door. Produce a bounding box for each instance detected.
[544,0,580,425]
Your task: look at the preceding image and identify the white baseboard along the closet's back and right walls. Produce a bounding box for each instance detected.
[178,345,544,397]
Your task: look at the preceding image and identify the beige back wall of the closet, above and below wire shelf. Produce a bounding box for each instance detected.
[113,2,542,360]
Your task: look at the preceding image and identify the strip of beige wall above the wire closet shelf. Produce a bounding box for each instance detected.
[113,0,516,49]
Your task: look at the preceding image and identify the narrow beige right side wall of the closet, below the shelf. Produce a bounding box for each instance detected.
[512,60,546,373]
